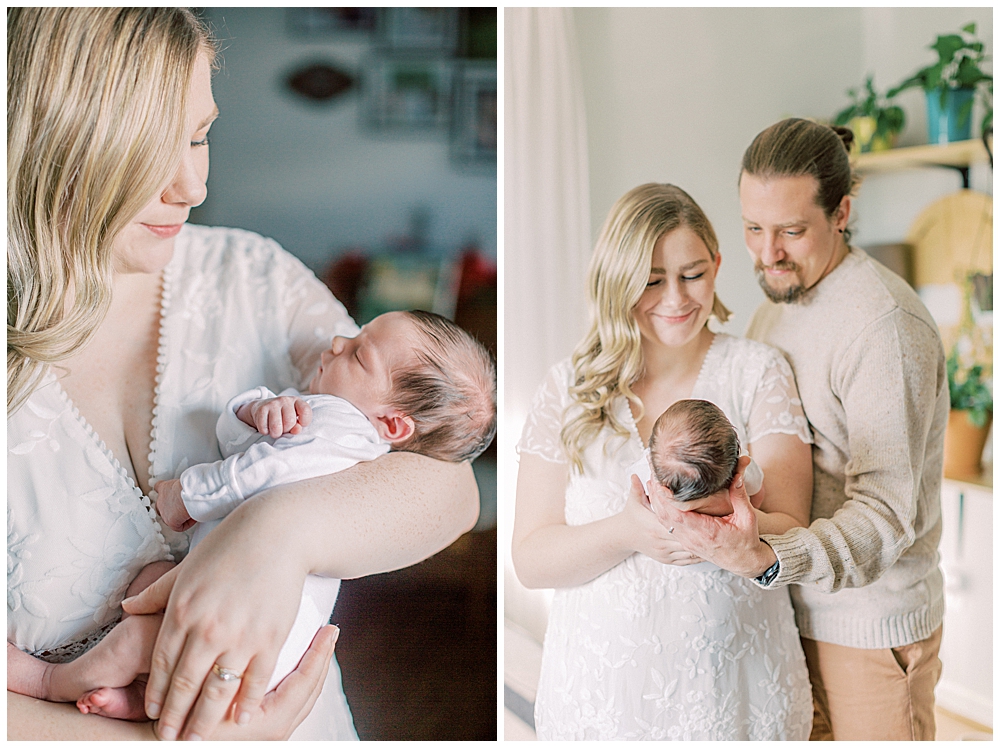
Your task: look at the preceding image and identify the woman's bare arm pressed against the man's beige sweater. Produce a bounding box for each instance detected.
[748,434,812,535]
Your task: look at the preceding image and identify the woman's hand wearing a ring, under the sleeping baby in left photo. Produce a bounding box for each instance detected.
[122,501,308,740]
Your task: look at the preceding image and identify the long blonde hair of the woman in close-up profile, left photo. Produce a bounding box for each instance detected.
[7,8,215,417]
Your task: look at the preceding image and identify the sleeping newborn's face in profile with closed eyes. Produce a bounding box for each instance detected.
[309,312,414,421]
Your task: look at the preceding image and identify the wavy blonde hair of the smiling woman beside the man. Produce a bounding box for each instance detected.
[561,183,729,471]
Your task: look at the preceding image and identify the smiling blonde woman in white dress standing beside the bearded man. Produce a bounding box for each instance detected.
[513,184,812,740]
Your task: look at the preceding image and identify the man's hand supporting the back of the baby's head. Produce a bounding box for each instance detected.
[647,456,777,578]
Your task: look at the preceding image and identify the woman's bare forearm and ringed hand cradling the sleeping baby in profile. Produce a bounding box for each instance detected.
[126,452,479,736]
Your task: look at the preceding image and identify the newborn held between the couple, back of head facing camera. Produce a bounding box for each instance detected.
[629,400,764,517]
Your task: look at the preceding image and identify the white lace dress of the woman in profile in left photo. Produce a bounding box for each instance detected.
[7,225,357,740]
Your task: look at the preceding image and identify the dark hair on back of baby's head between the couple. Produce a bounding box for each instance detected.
[649,400,740,501]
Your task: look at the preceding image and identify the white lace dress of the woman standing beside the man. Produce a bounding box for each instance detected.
[518,334,813,740]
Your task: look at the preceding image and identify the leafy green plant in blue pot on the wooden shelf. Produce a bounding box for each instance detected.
[887,23,993,143]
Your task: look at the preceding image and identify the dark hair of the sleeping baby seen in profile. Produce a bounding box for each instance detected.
[389,310,497,462]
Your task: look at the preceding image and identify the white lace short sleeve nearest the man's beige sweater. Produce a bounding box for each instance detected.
[747,348,813,444]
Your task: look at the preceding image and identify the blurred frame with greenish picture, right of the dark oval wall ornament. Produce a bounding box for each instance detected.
[362,56,453,131]
